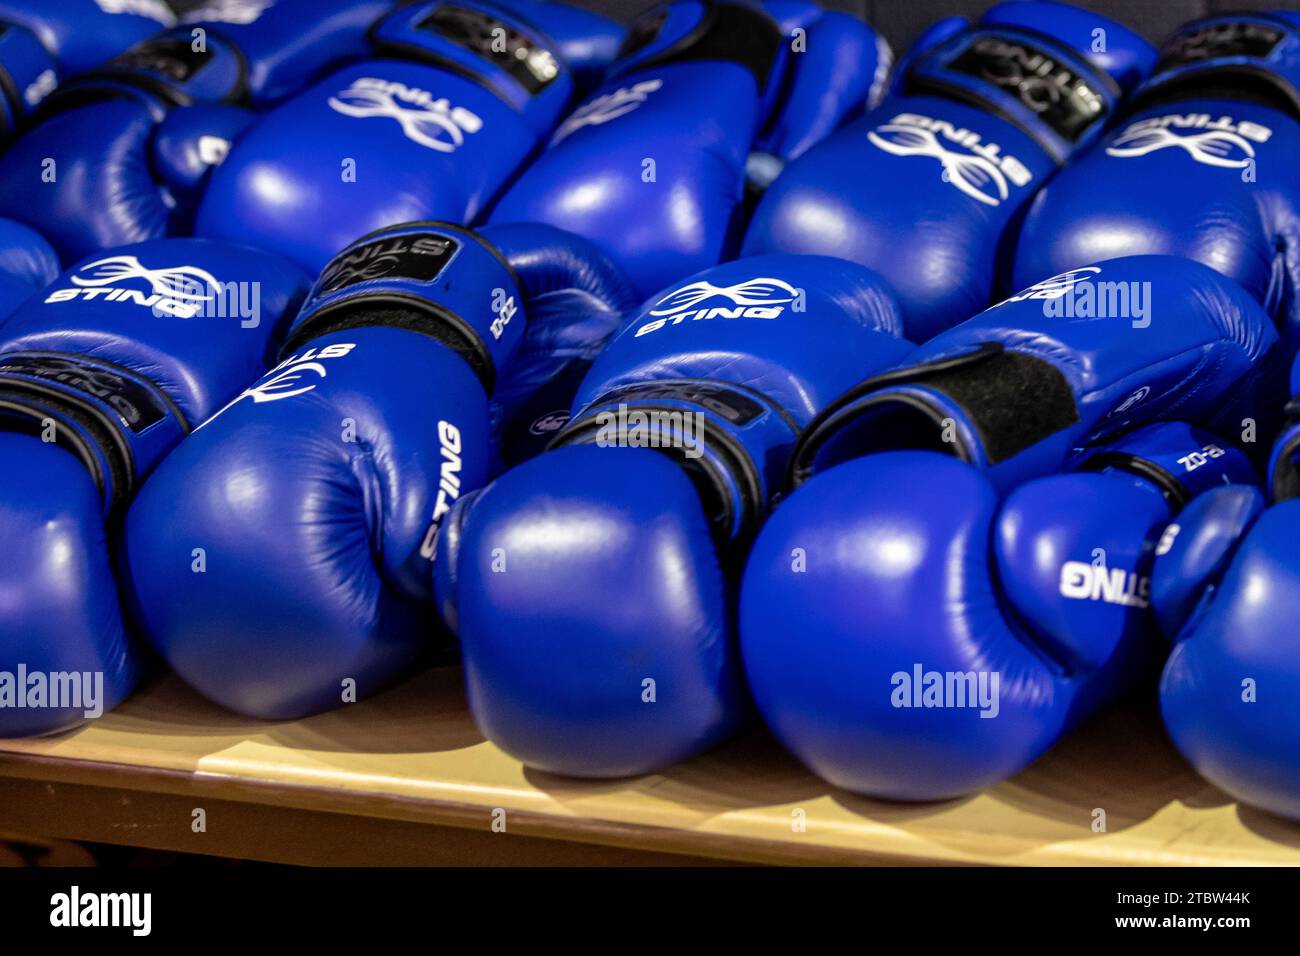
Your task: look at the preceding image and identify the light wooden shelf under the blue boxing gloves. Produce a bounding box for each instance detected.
[0,669,1300,865]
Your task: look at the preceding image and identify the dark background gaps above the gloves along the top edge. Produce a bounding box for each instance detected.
[568,0,1300,53]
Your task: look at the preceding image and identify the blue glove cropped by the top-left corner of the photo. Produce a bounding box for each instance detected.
[0,0,177,77]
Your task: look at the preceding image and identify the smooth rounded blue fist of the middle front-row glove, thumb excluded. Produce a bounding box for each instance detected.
[458,446,742,777]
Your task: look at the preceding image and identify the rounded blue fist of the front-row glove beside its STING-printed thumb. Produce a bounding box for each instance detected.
[741,453,1069,800]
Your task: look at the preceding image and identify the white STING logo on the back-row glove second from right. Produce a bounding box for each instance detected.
[867,113,1034,206]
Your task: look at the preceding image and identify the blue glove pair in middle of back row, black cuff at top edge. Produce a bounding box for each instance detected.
[490,0,888,297]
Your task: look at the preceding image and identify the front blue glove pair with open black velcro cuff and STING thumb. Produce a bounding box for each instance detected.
[740,256,1279,800]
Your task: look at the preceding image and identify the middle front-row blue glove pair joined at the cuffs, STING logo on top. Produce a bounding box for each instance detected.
[434,256,911,777]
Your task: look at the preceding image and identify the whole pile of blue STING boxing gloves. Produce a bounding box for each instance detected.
[0,0,1300,818]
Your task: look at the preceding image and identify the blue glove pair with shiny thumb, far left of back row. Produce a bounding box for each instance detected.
[0,0,389,260]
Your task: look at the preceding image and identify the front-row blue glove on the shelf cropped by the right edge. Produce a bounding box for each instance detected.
[1152,340,1300,819]
